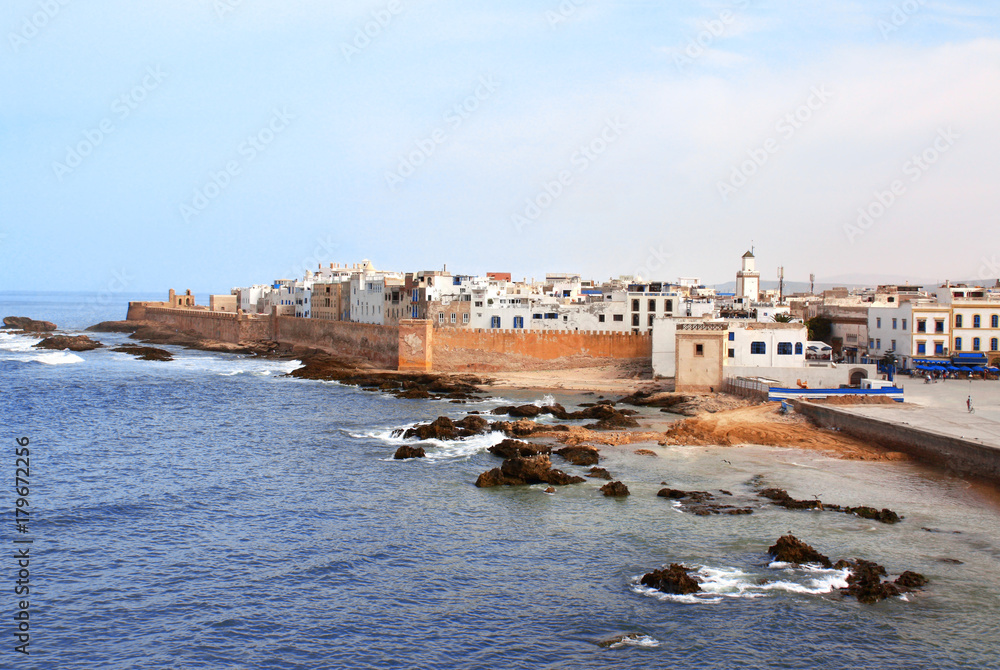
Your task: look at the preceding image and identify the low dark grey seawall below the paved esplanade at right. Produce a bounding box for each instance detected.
[793,400,1000,484]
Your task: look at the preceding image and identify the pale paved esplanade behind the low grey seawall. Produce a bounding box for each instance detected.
[837,377,1000,449]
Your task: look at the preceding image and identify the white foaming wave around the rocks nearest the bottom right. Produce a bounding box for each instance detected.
[630,563,850,604]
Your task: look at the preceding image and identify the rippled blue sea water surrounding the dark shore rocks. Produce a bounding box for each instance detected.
[0,293,1000,670]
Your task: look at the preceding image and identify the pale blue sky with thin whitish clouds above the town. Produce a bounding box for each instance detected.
[0,0,1000,293]
